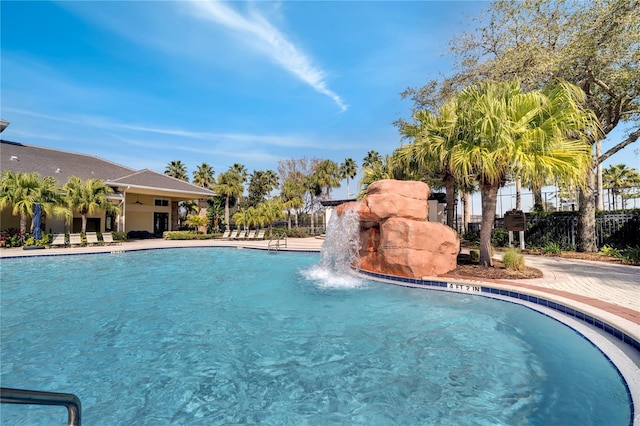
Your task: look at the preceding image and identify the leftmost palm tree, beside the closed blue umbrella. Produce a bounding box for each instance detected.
[0,170,71,234]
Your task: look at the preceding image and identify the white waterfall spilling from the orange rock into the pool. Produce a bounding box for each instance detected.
[302,201,363,288]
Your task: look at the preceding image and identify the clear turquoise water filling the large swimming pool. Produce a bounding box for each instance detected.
[0,248,631,426]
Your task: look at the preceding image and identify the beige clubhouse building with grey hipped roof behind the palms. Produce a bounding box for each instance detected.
[0,140,215,235]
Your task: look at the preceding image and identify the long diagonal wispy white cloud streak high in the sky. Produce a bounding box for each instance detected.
[187,0,348,112]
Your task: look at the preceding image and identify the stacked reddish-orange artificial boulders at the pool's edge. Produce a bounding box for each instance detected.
[336,179,460,279]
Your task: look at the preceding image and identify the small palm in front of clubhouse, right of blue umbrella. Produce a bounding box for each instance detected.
[63,176,118,233]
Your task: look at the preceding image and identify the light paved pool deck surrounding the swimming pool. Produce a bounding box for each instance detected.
[0,238,640,341]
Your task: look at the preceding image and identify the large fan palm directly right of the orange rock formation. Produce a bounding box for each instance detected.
[450,81,599,266]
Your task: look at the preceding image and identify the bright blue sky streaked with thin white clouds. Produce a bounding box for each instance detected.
[0,0,638,207]
